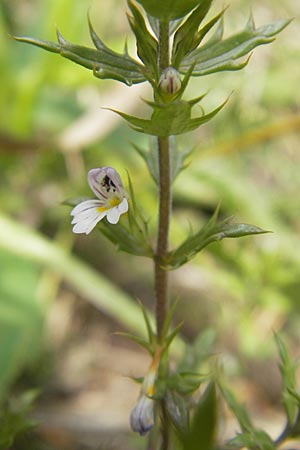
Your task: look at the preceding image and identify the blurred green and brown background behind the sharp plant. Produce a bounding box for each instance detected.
[0,0,300,449]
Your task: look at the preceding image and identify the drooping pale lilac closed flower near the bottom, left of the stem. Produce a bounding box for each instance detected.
[130,394,154,436]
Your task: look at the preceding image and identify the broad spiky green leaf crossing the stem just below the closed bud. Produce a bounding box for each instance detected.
[111,96,227,137]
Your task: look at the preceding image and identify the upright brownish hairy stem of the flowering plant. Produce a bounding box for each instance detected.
[155,22,171,450]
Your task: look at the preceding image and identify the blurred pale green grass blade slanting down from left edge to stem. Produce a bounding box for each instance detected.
[0,214,184,354]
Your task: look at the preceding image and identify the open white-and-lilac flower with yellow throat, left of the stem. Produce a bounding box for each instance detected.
[71,167,128,234]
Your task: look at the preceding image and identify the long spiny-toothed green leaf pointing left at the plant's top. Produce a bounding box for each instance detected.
[15,22,145,86]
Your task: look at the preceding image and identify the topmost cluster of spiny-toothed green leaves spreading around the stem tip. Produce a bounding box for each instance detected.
[12,0,289,89]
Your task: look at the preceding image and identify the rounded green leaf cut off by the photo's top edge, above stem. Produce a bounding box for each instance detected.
[137,0,201,21]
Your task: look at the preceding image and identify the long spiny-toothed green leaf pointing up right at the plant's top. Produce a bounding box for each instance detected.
[179,18,291,76]
